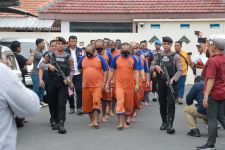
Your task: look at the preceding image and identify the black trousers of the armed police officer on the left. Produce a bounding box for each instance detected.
[48,78,68,122]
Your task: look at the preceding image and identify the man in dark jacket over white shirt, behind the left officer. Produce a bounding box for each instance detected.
[64,36,82,115]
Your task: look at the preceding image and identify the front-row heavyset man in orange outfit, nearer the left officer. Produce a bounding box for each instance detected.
[78,44,108,129]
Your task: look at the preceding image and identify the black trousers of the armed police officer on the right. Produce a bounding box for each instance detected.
[157,78,175,122]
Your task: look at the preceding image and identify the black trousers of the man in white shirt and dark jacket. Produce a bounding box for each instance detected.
[68,74,82,109]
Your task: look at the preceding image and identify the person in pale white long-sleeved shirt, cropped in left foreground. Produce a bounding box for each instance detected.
[0,47,40,150]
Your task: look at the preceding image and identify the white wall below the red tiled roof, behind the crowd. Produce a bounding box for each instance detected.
[0,21,225,83]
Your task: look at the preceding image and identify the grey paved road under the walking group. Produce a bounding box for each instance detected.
[17,85,225,150]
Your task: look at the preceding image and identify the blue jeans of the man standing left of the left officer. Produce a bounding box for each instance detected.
[31,74,45,102]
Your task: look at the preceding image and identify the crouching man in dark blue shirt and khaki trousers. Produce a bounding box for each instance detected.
[184,76,208,137]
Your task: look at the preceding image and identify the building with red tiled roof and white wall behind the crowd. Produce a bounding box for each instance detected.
[0,0,225,83]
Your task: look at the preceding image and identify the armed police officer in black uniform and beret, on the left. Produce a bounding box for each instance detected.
[49,37,73,134]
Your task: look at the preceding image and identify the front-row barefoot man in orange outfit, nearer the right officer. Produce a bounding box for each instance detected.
[105,43,139,130]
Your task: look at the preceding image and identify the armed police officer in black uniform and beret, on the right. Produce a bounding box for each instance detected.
[152,36,182,134]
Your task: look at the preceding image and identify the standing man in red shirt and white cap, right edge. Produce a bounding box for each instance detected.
[197,35,225,150]
